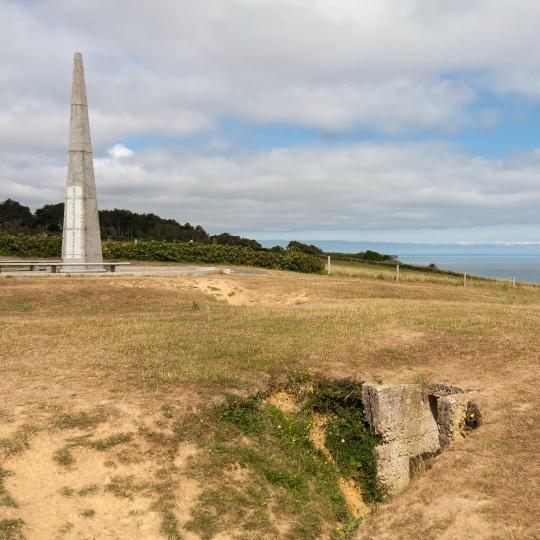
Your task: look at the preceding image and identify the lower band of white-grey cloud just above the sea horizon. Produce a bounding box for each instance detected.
[6,143,540,234]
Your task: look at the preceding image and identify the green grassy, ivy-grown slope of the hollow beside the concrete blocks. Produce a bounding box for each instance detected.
[181,373,384,539]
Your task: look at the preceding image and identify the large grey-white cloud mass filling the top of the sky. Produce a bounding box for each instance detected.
[0,0,540,144]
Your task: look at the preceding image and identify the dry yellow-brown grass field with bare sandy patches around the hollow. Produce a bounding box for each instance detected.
[0,269,540,540]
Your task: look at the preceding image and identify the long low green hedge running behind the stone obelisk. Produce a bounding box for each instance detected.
[0,232,323,272]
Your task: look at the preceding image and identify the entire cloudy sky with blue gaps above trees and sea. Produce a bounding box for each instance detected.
[0,0,540,242]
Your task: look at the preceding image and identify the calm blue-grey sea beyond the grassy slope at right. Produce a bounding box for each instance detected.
[265,240,540,283]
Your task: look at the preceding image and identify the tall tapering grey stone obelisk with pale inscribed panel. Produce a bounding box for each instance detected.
[62,53,103,272]
